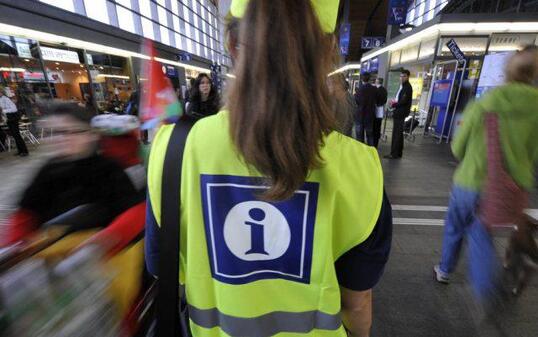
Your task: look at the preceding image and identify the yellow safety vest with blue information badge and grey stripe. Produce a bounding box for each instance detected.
[148,112,383,337]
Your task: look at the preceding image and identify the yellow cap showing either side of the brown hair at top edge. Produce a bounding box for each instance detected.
[230,0,340,33]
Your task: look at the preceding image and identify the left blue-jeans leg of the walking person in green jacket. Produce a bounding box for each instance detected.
[439,186,475,277]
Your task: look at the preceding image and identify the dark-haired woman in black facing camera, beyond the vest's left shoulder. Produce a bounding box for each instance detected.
[185,74,220,120]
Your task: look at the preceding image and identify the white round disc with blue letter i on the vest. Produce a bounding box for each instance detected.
[224,201,291,261]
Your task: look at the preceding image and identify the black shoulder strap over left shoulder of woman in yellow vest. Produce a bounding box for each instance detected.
[155,121,193,337]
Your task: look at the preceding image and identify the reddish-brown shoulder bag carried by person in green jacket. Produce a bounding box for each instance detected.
[479,113,529,229]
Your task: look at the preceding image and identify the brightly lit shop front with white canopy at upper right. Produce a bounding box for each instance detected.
[361,14,538,142]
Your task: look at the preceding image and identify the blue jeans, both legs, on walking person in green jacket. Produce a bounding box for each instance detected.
[440,185,500,300]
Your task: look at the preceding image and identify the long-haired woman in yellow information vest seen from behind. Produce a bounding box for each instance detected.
[146,0,392,337]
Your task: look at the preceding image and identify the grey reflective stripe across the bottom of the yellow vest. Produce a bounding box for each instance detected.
[189,305,342,337]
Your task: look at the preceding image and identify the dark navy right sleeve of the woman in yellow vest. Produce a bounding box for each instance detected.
[335,190,392,291]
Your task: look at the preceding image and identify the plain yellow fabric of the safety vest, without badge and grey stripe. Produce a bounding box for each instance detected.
[148,112,383,337]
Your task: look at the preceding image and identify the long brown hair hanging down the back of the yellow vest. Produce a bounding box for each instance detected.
[228,0,335,201]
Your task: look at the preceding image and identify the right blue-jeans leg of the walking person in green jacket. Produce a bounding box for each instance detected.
[468,215,500,303]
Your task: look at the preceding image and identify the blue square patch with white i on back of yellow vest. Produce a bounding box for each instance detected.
[201,175,319,284]
